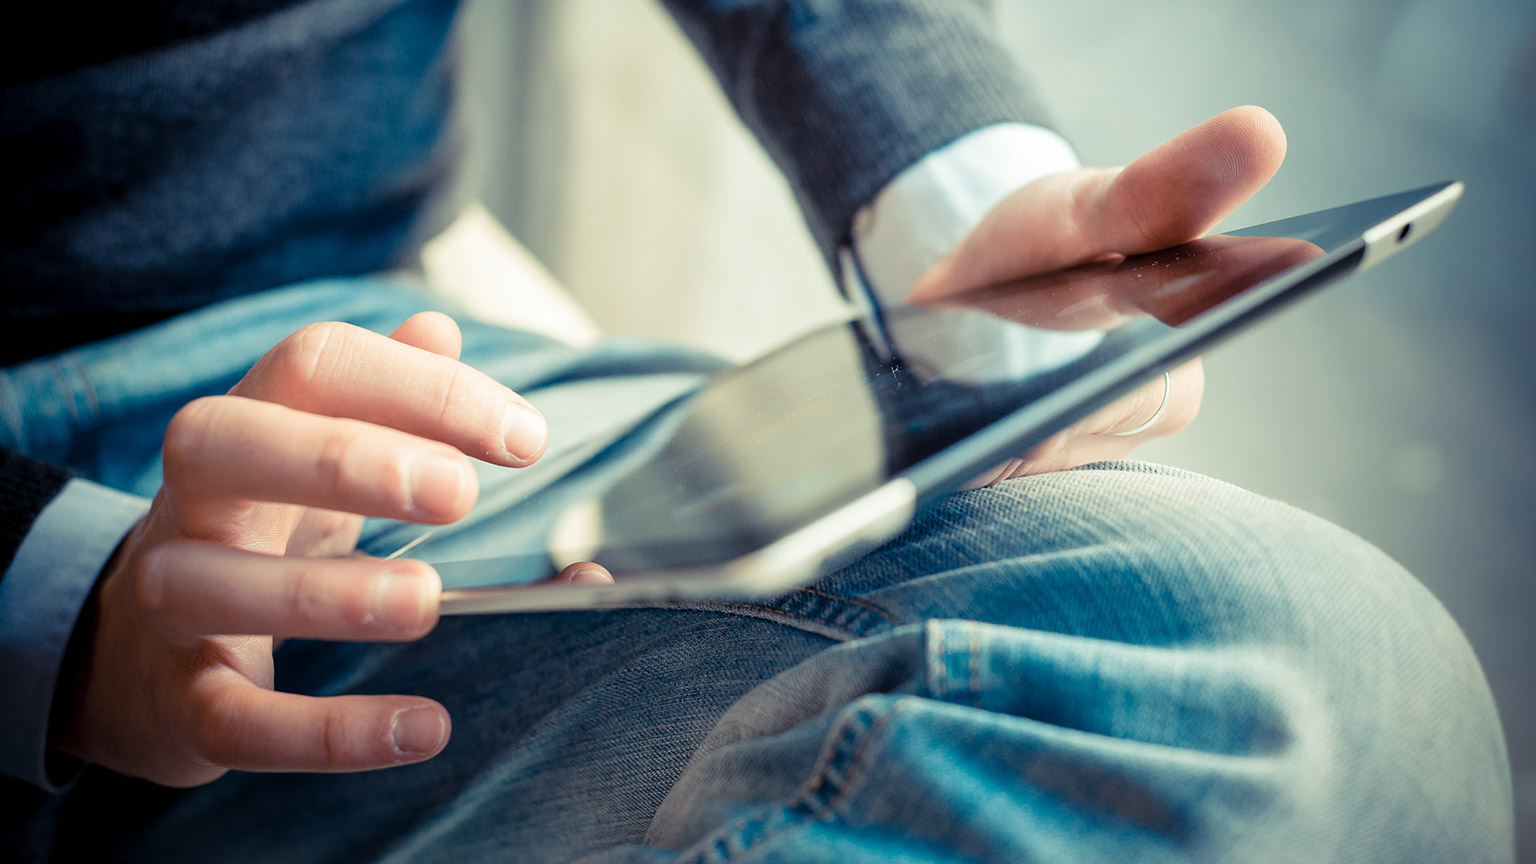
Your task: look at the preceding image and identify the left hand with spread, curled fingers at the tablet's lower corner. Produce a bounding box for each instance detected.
[54,312,548,786]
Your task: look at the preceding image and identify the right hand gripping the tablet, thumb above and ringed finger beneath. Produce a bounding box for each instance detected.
[911,106,1286,473]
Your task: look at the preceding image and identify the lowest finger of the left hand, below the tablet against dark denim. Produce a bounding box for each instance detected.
[190,670,452,772]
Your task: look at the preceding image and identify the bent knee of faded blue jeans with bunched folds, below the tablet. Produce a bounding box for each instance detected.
[635,463,1513,862]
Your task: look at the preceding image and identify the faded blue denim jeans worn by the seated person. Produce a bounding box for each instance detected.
[0,278,1513,864]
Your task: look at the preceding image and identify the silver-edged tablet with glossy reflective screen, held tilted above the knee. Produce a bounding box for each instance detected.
[433,181,1462,615]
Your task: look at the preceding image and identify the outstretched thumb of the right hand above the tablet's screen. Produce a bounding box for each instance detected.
[912,106,1286,300]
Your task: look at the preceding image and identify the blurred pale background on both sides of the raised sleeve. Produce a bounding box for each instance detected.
[465,0,1536,861]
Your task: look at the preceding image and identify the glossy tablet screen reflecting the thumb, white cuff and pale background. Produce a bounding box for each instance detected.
[439,184,1443,578]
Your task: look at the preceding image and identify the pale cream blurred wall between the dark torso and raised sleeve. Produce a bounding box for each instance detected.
[457,0,842,358]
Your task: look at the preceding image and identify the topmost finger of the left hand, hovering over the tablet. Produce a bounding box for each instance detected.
[230,315,548,466]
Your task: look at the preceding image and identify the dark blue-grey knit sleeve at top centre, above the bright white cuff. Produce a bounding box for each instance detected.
[664,0,1048,265]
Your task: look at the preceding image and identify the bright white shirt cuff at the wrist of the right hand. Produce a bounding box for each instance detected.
[852,123,1081,304]
